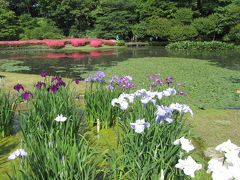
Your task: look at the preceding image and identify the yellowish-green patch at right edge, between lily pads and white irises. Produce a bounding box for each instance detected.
[189,109,240,147]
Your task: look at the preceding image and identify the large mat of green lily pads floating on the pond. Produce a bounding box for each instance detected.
[101,57,240,109]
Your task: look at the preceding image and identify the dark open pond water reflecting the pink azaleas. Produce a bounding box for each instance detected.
[0,47,240,78]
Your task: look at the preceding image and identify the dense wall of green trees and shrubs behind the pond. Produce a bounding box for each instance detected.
[0,0,240,44]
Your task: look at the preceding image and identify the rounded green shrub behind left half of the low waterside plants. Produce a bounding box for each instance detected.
[169,25,198,42]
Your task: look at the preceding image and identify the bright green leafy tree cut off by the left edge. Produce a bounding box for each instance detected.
[0,9,19,40]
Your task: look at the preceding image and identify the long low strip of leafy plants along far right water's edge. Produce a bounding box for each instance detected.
[166,41,235,50]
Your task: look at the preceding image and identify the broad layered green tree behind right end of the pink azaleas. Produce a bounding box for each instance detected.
[94,0,137,39]
